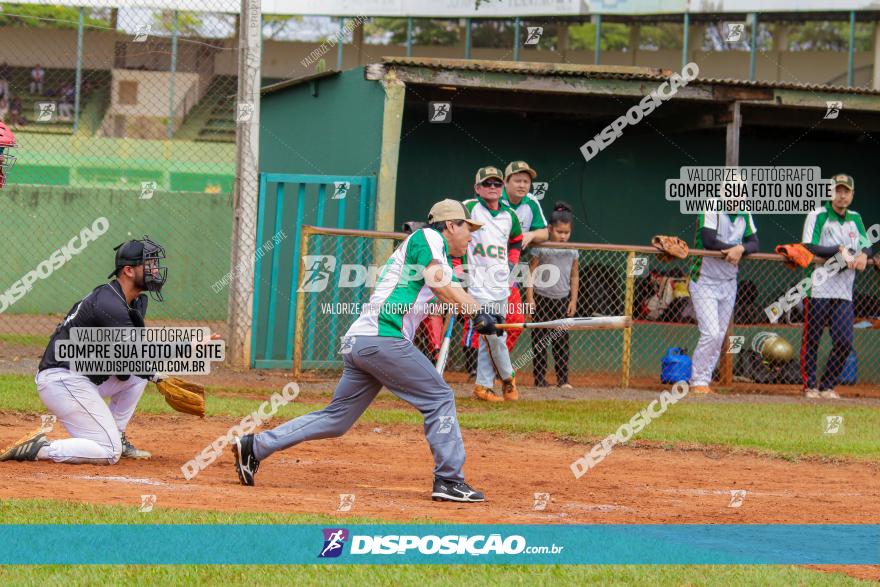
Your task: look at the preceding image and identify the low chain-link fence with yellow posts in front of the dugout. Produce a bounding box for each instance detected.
[294,228,880,395]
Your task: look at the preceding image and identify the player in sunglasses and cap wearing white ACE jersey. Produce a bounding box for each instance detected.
[464,167,522,402]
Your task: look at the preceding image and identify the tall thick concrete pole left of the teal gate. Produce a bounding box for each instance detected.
[228,0,262,367]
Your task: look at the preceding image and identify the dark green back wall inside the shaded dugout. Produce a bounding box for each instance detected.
[395,101,880,251]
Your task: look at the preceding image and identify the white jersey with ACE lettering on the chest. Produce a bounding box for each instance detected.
[462,198,522,300]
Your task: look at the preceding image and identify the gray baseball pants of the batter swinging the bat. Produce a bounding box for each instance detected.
[254,336,465,481]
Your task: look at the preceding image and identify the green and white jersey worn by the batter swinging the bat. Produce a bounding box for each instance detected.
[345,228,458,341]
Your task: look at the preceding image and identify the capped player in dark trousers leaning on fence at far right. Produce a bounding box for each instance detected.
[801,173,871,399]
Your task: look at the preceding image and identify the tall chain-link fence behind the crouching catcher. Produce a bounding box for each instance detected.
[0,0,260,372]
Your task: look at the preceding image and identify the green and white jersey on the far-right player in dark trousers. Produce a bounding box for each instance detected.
[801,202,871,301]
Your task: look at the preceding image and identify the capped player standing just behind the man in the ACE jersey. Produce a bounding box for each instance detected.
[501,161,550,351]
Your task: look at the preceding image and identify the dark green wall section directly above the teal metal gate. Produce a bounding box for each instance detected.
[260,68,385,175]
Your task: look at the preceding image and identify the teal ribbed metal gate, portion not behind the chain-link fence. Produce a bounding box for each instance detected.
[251,173,376,369]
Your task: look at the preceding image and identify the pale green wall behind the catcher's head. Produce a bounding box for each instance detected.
[0,185,232,321]
